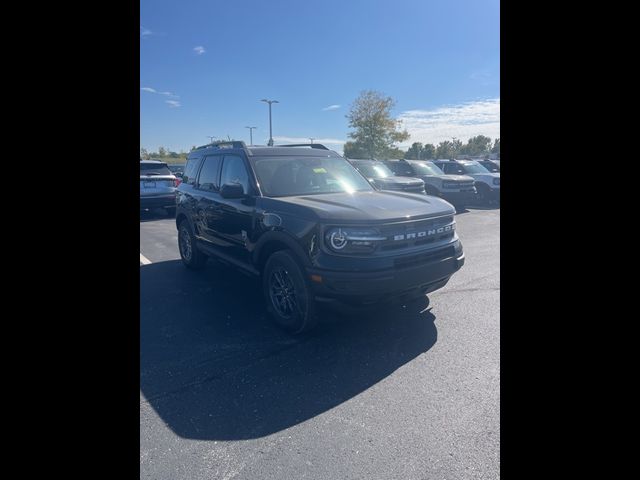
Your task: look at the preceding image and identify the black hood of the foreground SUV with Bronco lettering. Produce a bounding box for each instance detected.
[261,191,455,222]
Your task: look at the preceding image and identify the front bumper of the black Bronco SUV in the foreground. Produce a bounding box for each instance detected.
[307,244,464,304]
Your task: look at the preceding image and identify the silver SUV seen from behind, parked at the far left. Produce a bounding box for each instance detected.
[140,160,178,215]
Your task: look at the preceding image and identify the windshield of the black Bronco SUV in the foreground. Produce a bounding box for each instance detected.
[251,157,374,197]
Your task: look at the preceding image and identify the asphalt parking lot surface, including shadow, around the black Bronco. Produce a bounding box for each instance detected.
[140,208,500,480]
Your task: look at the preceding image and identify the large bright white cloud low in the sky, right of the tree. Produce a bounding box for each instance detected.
[398,98,500,148]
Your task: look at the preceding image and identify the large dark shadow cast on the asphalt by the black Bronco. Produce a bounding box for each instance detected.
[140,261,437,440]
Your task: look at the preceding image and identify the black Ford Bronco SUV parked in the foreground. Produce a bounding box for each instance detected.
[176,142,464,332]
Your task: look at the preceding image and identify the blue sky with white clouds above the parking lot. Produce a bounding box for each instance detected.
[140,0,500,151]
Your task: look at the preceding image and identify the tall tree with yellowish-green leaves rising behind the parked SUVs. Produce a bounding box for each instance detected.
[345,90,409,158]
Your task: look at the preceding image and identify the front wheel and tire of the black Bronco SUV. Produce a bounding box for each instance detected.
[262,250,317,334]
